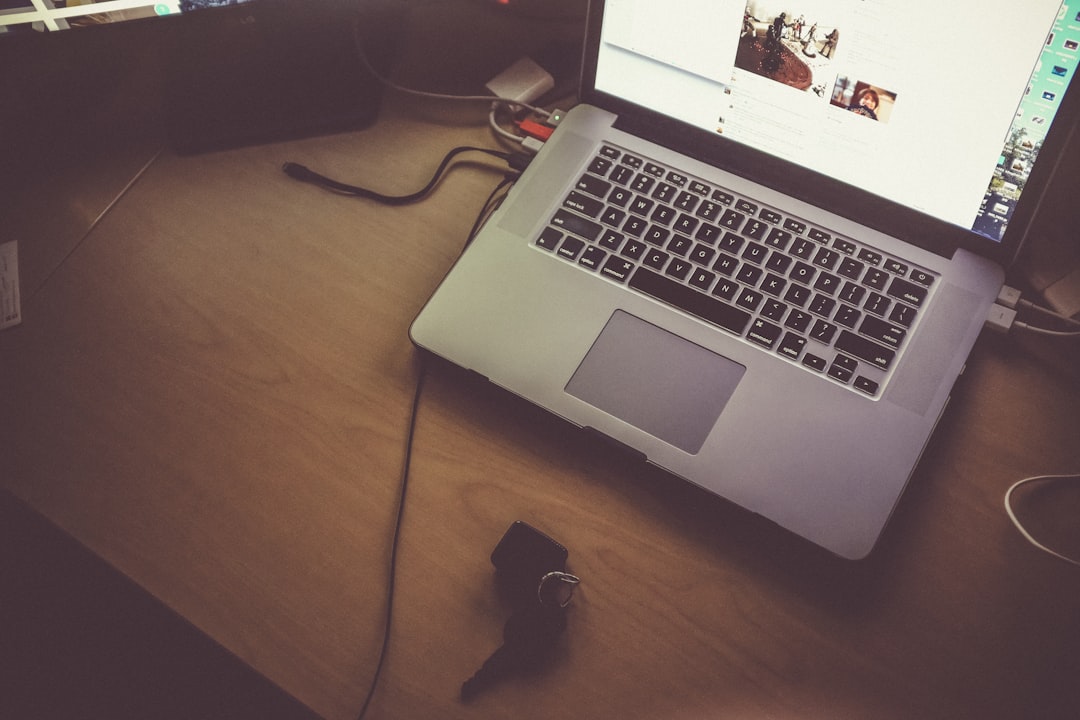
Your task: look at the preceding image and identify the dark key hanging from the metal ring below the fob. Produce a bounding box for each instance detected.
[461,602,566,701]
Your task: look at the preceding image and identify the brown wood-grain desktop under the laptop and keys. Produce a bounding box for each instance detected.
[0,11,1080,720]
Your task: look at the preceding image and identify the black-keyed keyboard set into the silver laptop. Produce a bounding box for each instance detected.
[536,146,934,397]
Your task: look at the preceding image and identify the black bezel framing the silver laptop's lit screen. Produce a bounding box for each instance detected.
[581,0,1080,266]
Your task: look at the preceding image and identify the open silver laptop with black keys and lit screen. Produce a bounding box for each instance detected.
[410,0,1080,559]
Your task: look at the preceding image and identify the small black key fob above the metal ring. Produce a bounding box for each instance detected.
[491,520,569,607]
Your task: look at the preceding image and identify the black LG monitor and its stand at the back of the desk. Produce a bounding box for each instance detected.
[0,0,404,152]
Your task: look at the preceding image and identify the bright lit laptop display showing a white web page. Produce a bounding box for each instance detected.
[595,0,1080,246]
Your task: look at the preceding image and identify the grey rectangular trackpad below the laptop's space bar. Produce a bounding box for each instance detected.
[566,310,746,453]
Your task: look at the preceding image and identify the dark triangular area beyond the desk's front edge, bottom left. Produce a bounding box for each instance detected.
[0,491,316,720]
